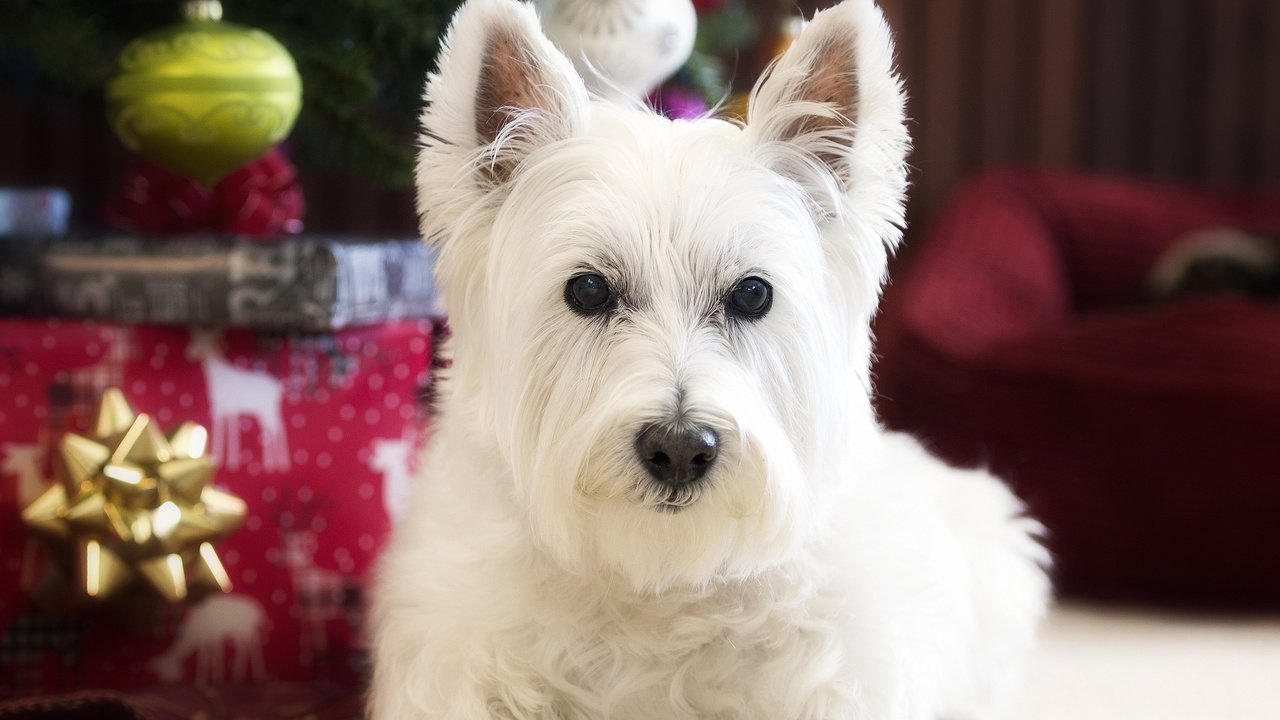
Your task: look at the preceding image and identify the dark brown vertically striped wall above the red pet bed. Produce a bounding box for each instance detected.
[855,0,1280,243]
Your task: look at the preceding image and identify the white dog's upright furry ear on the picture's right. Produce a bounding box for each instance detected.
[748,0,910,224]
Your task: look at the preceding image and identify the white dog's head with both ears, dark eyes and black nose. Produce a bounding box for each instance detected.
[417,0,908,588]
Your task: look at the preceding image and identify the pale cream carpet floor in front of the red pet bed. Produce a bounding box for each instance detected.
[1007,606,1280,720]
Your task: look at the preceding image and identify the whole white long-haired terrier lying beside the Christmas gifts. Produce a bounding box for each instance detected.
[371,0,1047,720]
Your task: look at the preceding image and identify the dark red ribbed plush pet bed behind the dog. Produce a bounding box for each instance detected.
[876,172,1280,607]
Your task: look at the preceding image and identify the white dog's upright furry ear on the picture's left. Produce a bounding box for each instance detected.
[417,0,588,235]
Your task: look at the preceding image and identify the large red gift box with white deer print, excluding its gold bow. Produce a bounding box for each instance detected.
[0,319,435,697]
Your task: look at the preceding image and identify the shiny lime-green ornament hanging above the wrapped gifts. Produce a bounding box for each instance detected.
[106,0,302,187]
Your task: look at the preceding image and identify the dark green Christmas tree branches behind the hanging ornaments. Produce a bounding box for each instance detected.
[0,0,755,187]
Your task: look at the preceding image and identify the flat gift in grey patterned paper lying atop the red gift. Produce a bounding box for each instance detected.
[0,236,435,332]
